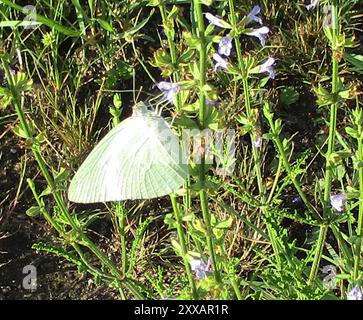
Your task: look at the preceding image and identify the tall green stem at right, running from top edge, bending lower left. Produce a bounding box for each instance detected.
[308,0,339,284]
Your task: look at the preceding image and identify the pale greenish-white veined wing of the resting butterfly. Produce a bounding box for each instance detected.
[68,116,187,203]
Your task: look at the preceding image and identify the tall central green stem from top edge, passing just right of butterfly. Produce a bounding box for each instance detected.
[193,0,221,283]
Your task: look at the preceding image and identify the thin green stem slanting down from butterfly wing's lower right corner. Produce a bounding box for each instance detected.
[170,194,198,299]
